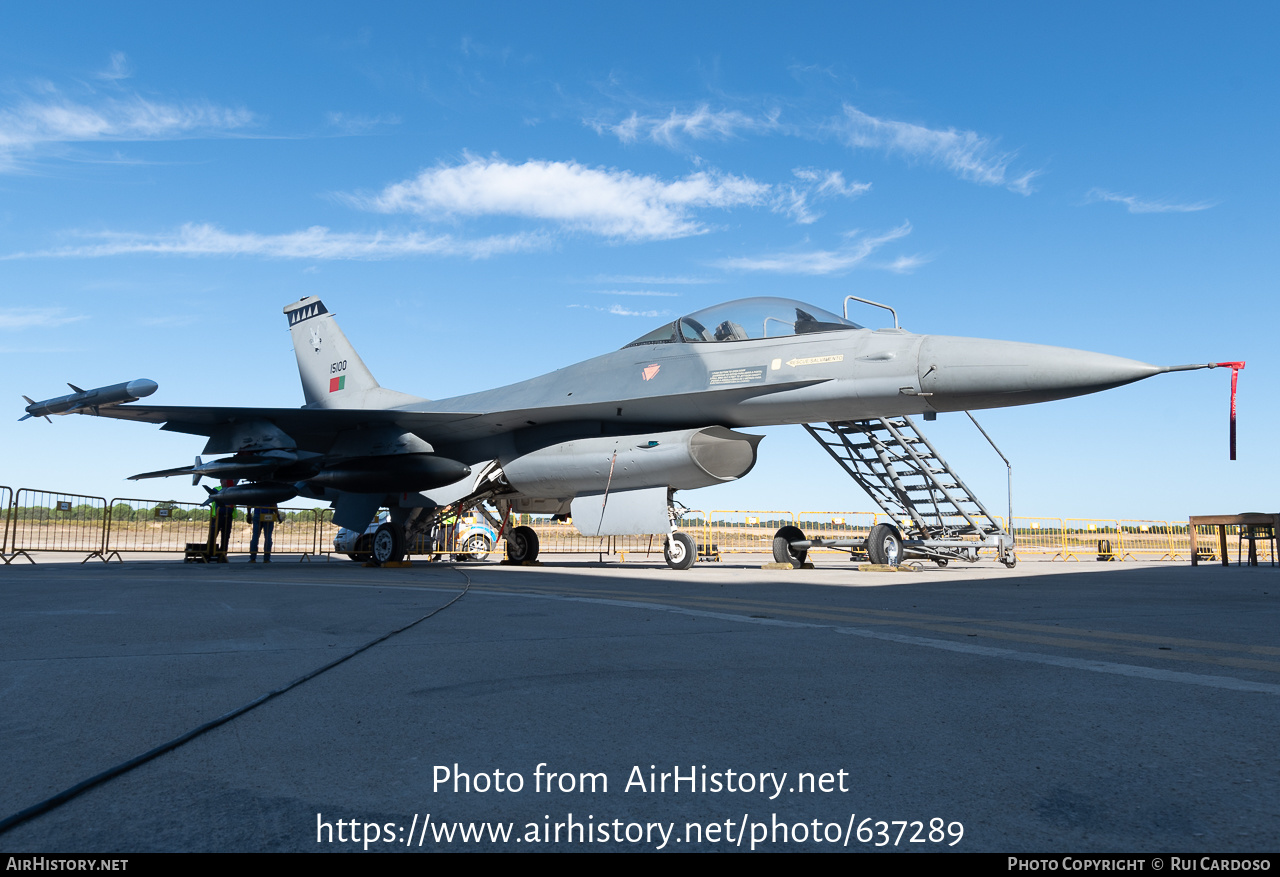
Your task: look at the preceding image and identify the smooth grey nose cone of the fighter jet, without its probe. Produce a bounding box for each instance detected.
[919,335,1162,411]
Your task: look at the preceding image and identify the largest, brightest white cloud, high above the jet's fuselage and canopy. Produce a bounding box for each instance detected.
[350,156,867,241]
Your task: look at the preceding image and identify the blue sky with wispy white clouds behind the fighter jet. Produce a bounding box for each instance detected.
[0,3,1280,520]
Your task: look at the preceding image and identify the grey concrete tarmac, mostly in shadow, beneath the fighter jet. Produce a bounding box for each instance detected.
[0,556,1280,854]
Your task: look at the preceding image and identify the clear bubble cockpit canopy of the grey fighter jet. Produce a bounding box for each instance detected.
[627,297,863,347]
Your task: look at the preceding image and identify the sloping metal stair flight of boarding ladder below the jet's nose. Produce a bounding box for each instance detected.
[804,415,1014,566]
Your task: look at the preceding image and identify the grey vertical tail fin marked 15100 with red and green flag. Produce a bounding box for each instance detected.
[284,296,422,408]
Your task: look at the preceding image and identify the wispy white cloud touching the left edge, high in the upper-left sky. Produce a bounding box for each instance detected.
[0,52,255,170]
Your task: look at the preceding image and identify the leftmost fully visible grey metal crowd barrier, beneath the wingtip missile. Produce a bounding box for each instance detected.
[6,488,108,563]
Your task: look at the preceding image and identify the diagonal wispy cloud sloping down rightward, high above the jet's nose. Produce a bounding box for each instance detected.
[835,104,1039,195]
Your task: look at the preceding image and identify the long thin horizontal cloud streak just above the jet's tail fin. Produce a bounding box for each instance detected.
[0,223,549,260]
